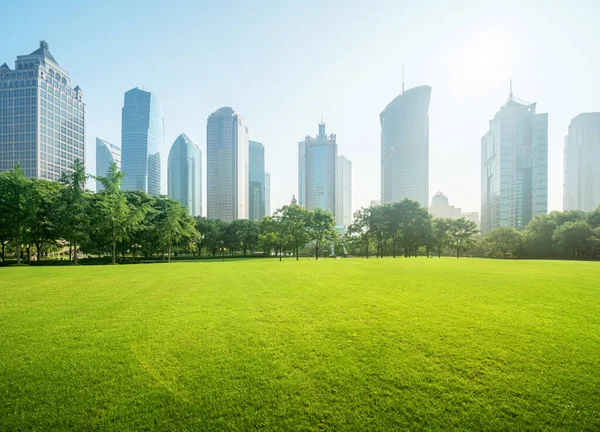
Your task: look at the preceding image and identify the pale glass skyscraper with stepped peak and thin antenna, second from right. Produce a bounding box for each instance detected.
[481,91,548,235]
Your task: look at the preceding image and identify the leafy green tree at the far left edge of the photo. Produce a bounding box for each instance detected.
[0,164,36,264]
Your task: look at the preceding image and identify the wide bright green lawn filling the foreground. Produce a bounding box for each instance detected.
[0,258,600,431]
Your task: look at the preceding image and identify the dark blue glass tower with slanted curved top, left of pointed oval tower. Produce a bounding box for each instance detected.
[121,87,166,195]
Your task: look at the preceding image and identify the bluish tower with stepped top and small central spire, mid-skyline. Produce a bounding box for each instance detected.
[298,123,337,217]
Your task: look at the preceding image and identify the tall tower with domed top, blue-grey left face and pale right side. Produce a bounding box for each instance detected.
[206,107,249,222]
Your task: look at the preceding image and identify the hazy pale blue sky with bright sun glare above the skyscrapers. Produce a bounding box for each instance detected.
[0,0,600,215]
